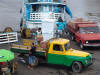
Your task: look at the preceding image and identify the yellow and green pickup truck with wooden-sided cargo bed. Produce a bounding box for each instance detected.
[11,38,92,72]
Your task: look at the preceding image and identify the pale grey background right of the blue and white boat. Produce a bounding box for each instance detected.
[67,0,100,18]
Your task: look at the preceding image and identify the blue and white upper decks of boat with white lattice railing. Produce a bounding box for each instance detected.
[22,0,66,29]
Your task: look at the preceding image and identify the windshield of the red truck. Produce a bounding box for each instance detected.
[80,26,100,34]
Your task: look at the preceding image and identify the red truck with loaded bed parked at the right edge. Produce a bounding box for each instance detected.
[67,20,100,49]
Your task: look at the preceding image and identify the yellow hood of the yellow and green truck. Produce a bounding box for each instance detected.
[66,49,90,57]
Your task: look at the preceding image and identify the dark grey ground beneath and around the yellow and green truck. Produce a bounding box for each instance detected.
[0,36,100,75]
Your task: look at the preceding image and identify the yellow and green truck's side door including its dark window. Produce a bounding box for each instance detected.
[48,44,64,64]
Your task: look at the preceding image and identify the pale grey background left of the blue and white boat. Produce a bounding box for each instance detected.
[0,0,22,31]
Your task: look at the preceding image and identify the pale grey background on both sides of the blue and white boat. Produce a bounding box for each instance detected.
[0,0,100,31]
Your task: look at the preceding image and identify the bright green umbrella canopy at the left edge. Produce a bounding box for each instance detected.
[0,49,14,62]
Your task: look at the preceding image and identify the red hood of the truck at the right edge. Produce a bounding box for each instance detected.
[80,33,100,40]
